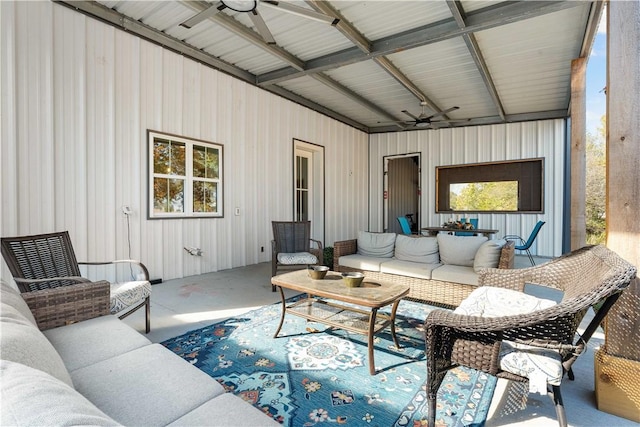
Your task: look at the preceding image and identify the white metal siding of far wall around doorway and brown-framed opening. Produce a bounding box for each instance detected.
[369,119,565,256]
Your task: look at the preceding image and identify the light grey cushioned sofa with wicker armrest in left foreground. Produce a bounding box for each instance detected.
[0,282,279,426]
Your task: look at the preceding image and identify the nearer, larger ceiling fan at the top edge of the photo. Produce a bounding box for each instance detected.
[180,0,340,44]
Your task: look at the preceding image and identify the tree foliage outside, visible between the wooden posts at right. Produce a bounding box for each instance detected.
[585,116,607,245]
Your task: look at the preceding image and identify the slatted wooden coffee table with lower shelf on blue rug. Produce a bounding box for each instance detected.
[271,270,409,375]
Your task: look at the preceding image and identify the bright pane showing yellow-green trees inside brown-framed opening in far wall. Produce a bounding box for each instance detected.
[449,181,518,211]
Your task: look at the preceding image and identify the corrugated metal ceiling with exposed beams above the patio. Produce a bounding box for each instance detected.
[58,0,603,133]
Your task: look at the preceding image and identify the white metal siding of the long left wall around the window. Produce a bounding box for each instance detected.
[0,2,368,280]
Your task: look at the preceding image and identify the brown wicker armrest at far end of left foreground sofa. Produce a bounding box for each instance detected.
[22,281,110,331]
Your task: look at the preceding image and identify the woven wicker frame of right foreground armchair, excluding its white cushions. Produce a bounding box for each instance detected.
[425,246,636,427]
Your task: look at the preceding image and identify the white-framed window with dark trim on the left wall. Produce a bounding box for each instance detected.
[147,130,224,219]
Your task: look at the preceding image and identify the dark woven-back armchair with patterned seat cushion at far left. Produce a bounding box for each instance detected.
[1,231,151,333]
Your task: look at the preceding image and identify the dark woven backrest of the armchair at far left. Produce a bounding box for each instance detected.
[1,231,80,292]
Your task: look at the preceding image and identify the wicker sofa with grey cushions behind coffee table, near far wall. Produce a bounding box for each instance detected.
[333,231,514,307]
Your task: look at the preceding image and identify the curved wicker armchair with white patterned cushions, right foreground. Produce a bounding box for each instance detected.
[425,246,637,427]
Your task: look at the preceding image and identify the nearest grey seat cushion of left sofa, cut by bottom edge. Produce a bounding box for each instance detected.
[169,393,281,427]
